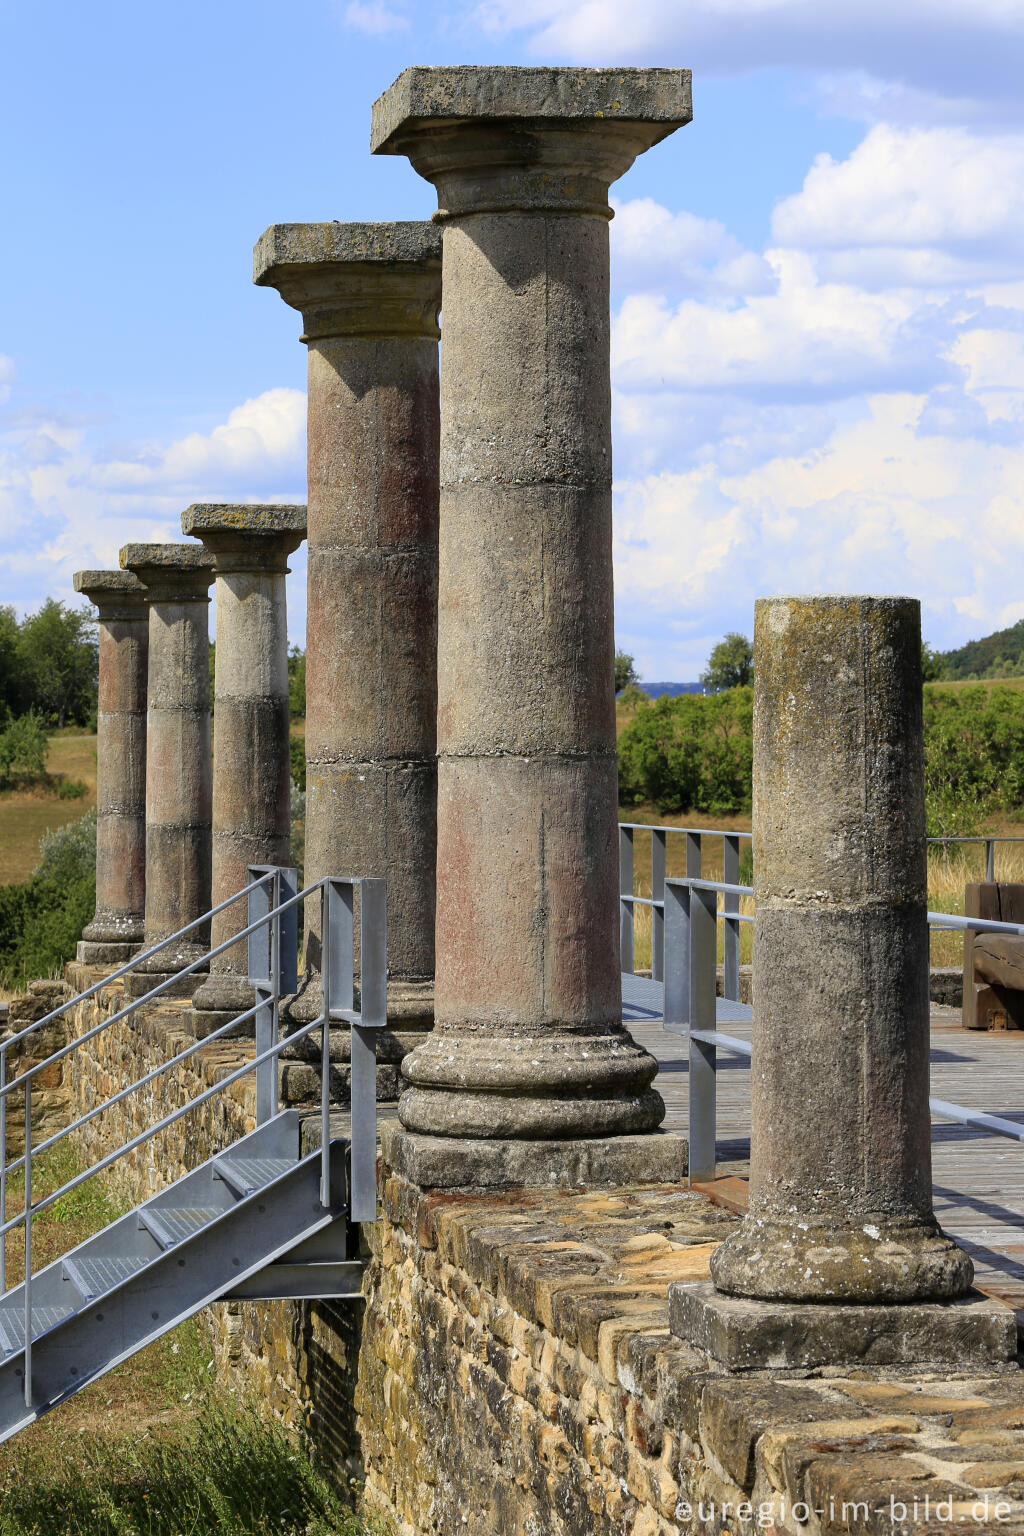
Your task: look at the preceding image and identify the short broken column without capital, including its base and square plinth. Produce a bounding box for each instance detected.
[674,598,1015,1366]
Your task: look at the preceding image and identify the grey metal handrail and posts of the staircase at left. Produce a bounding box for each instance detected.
[0,865,387,1407]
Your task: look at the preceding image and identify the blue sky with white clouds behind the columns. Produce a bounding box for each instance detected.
[0,0,1024,680]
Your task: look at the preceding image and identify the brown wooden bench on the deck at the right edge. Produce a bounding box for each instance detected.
[963,880,1024,1029]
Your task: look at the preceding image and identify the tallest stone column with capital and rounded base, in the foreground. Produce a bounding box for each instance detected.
[372,68,691,1155]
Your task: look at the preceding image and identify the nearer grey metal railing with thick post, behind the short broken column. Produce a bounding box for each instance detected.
[663,877,1024,1184]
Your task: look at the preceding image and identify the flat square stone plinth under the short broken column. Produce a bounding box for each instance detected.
[668,1284,1016,1375]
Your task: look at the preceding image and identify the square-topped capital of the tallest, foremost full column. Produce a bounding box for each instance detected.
[370,65,692,221]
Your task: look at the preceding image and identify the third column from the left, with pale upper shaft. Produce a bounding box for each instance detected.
[181,505,306,1032]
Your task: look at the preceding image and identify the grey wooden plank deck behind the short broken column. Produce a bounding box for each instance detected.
[623,977,1024,1321]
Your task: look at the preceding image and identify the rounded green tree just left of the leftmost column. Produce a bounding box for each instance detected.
[18,598,98,727]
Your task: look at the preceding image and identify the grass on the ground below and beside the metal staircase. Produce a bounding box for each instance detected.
[0,1141,387,1536]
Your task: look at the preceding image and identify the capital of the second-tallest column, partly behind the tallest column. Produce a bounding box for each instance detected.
[252,221,441,341]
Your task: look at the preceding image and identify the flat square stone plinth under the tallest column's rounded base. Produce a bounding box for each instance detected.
[381,1120,688,1189]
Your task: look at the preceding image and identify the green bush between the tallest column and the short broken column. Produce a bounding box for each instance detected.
[619,688,754,816]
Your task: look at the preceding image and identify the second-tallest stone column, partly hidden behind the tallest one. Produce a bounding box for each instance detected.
[253,224,441,1097]
